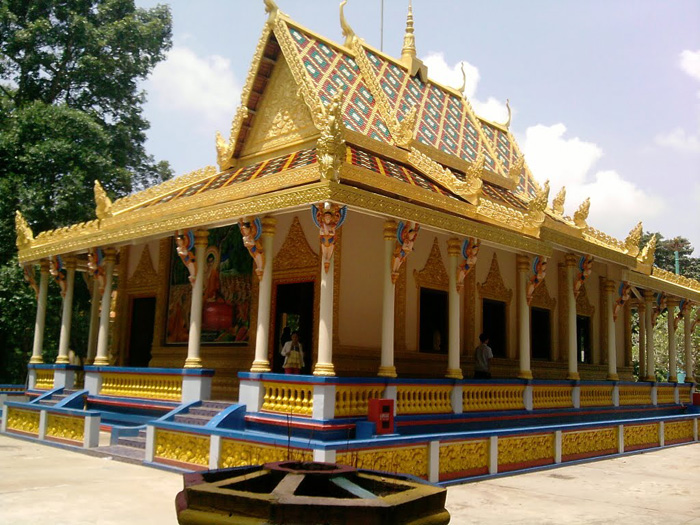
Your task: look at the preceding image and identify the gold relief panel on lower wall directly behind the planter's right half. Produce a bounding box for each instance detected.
[335,445,428,478]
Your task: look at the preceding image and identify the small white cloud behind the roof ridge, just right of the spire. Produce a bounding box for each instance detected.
[423,52,508,122]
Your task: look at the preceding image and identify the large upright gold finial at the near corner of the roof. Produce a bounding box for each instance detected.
[316,91,345,182]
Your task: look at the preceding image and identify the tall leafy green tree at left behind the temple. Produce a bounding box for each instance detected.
[0,0,172,380]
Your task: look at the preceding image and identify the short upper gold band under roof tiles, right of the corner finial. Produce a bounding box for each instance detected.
[341,164,478,219]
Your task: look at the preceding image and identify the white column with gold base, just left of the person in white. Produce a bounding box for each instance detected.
[250,217,277,373]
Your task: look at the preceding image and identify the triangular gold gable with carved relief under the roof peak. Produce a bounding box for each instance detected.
[242,55,318,157]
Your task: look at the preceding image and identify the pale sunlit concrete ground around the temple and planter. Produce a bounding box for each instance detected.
[0,436,700,525]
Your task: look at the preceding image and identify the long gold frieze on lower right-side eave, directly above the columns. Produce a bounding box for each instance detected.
[329,183,552,257]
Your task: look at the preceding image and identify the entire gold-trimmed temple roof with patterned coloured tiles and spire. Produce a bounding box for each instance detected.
[16,0,700,300]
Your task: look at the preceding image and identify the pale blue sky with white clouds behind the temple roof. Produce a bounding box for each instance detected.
[136,0,700,252]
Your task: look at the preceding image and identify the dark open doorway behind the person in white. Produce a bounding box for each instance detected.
[270,281,314,374]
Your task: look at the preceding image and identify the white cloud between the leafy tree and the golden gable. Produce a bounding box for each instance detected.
[146,45,241,131]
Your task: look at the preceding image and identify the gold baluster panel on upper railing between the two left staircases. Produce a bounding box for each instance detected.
[100,372,182,401]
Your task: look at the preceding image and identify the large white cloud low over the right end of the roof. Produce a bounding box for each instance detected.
[521,123,666,238]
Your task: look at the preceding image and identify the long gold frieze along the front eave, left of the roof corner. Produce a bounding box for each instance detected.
[20,183,331,262]
